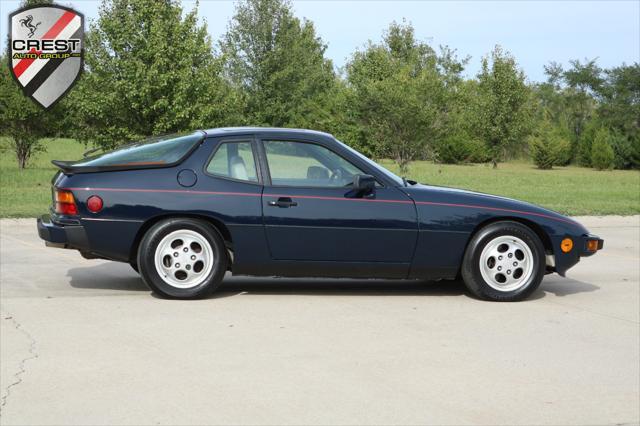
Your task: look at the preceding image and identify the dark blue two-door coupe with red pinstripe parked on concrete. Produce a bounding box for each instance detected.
[37,127,603,301]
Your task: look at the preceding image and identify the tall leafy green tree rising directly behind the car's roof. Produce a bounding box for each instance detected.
[221,0,336,128]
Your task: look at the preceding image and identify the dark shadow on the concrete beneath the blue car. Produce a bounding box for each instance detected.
[67,262,600,300]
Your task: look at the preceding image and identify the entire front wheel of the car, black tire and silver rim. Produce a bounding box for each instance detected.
[461,221,546,302]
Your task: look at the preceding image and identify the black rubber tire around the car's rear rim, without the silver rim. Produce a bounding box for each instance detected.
[137,218,228,299]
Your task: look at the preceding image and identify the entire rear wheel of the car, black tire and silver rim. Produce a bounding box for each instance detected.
[137,218,228,299]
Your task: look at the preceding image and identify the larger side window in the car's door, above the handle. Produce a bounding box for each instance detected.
[264,141,363,187]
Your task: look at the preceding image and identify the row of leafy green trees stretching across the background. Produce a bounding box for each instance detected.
[0,0,640,169]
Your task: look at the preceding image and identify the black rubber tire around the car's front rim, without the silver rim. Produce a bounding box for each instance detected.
[461,221,546,302]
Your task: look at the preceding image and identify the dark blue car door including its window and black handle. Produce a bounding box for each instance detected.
[260,138,417,267]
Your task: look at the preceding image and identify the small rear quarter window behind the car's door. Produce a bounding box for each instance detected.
[206,142,258,182]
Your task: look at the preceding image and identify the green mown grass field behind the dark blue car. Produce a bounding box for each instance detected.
[0,139,640,217]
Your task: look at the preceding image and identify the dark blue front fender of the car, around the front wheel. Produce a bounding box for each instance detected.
[404,185,588,278]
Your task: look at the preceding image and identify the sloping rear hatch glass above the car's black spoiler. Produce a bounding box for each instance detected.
[72,131,204,168]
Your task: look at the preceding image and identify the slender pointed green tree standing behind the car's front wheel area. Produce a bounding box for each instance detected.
[475,46,531,167]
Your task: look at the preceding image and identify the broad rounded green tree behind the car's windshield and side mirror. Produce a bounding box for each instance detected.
[347,23,452,173]
